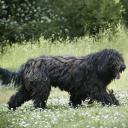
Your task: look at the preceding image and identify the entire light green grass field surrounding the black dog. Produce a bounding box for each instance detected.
[0,28,128,128]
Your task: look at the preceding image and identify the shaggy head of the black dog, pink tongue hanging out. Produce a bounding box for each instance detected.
[97,49,126,80]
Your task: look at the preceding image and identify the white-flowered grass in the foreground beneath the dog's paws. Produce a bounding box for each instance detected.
[0,90,128,128]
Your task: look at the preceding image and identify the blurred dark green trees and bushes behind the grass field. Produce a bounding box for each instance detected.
[0,0,128,51]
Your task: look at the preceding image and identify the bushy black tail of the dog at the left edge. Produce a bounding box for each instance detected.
[0,68,19,86]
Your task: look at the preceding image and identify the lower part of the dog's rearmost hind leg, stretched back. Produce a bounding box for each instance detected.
[8,86,30,110]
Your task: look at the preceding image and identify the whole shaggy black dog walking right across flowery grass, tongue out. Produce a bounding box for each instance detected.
[0,49,126,109]
